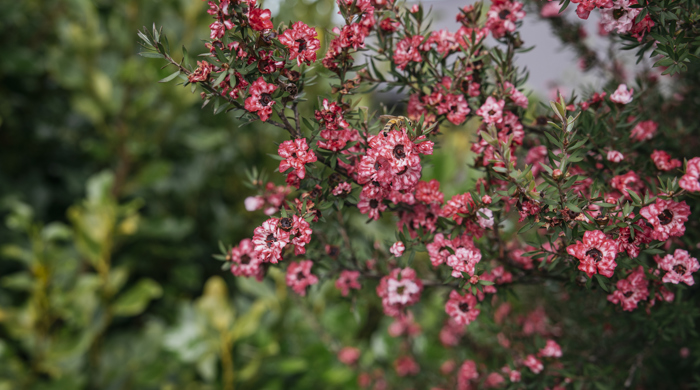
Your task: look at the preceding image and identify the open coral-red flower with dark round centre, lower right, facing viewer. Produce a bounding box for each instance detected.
[566,230,617,278]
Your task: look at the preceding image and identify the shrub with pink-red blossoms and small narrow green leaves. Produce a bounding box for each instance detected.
[140,0,700,389]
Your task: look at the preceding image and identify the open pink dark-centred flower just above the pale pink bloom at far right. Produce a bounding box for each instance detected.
[639,198,690,241]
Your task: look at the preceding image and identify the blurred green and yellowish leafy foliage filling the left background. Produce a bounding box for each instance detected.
[0,0,382,390]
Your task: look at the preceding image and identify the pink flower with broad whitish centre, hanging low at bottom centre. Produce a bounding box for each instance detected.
[377,268,423,317]
